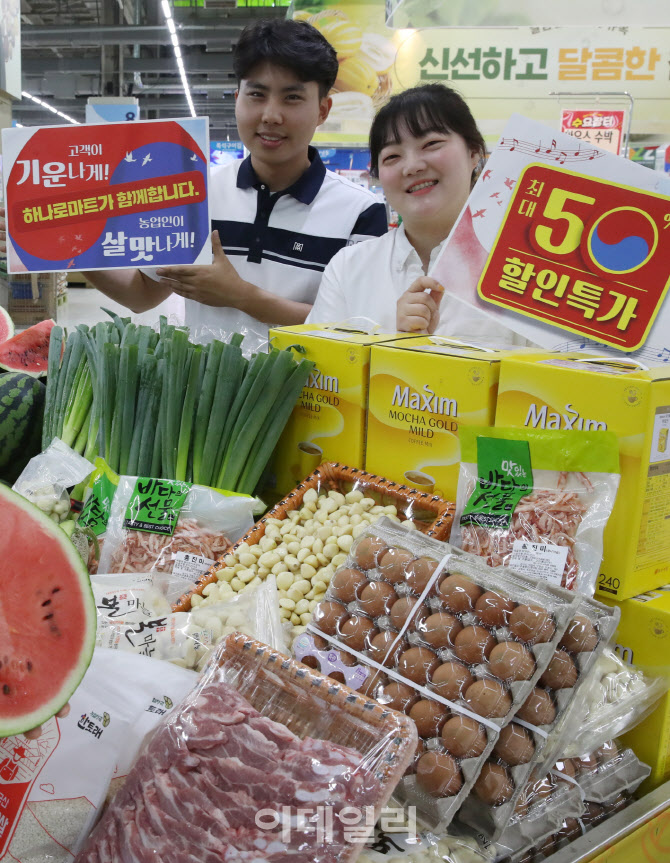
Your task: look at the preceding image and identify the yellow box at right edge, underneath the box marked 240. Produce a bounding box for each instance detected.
[605,584,670,794]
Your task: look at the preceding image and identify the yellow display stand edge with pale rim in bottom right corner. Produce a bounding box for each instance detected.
[547,782,670,863]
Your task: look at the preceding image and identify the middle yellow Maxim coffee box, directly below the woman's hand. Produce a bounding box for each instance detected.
[365,336,523,500]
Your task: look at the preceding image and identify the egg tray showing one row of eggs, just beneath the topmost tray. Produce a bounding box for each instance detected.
[459,597,619,839]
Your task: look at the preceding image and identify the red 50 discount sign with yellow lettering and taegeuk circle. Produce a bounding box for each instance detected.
[478,164,670,351]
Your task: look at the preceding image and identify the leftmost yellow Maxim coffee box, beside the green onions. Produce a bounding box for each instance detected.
[268,324,410,498]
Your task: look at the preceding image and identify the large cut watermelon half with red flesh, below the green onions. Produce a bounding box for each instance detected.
[0,484,96,737]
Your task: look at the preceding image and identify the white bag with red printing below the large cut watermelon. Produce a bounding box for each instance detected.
[0,650,196,863]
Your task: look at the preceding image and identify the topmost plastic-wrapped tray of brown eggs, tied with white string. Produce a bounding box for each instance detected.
[293,519,576,827]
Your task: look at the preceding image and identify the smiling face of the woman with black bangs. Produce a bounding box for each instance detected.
[379,126,480,237]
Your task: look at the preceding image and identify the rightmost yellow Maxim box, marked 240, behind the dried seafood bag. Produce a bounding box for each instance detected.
[495,352,670,600]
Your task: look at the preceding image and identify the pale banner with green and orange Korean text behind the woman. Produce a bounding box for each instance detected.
[293,0,670,144]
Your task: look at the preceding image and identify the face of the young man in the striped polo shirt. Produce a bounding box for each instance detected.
[235,63,330,191]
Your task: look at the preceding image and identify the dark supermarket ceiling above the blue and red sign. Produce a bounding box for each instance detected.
[12,0,286,135]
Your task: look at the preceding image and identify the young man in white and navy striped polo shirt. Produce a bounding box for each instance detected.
[53,19,386,334]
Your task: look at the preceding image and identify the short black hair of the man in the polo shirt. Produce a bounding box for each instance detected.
[233,18,337,98]
